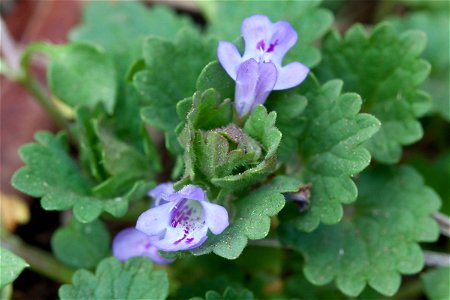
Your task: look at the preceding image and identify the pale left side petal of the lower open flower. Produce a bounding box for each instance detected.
[136,202,172,236]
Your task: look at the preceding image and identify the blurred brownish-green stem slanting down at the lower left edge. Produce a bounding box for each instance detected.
[1,235,75,283]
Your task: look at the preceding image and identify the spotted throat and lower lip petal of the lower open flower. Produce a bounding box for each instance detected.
[153,200,208,251]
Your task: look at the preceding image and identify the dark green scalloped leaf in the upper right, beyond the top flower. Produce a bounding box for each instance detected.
[318,24,431,164]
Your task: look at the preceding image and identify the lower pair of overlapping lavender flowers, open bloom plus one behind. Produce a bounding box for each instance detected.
[113,183,228,264]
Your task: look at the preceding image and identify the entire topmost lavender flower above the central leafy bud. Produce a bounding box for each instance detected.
[217,15,309,116]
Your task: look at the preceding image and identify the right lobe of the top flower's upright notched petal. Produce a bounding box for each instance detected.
[270,21,298,67]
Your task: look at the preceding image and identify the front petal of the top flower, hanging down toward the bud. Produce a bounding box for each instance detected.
[235,58,277,116]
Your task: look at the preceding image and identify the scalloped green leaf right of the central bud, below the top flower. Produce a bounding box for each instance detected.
[296,80,380,231]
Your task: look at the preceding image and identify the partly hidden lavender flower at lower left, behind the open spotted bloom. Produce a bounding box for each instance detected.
[113,228,173,265]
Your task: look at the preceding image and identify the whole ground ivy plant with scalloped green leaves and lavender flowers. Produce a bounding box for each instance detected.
[0,1,449,300]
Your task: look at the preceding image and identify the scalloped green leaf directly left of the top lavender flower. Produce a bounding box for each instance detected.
[133,30,216,152]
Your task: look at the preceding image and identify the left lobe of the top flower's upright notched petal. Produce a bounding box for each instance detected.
[241,15,273,60]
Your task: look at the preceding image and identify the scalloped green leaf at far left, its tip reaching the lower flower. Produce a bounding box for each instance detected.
[12,132,148,223]
